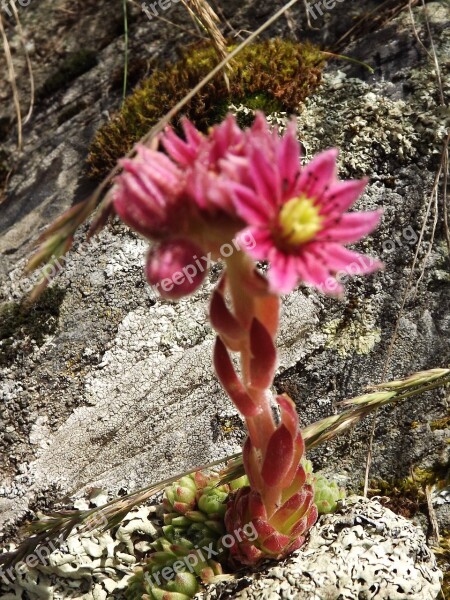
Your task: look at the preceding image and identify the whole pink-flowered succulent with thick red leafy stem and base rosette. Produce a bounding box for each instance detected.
[113,113,381,597]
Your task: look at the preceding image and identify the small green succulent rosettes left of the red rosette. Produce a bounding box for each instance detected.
[127,471,230,600]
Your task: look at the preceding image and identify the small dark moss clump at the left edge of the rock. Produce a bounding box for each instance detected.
[0,286,65,367]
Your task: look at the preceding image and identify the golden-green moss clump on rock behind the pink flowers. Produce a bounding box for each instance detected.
[88,39,325,177]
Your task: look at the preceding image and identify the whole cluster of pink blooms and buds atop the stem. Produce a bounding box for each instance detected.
[114,113,380,299]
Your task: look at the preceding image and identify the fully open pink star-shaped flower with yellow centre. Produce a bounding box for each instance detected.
[230,114,382,294]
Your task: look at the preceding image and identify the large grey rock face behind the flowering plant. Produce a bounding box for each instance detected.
[0,0,450,596]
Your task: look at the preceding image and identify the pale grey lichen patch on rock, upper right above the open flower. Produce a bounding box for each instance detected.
[298,71,420,175]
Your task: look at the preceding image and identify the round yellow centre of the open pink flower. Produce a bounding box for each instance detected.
[279,196,323,244]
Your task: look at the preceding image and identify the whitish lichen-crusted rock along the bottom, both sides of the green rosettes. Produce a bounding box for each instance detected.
[0,497,442,600]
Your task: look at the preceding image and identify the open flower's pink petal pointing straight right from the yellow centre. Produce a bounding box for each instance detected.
[316,210,382,244]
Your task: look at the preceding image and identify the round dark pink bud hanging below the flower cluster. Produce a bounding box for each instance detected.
[145,239,206,300]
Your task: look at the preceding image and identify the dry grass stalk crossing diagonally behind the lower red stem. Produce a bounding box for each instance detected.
[0,369,450,567]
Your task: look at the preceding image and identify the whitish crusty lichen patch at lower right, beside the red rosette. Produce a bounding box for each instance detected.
[200,497,442,600]
